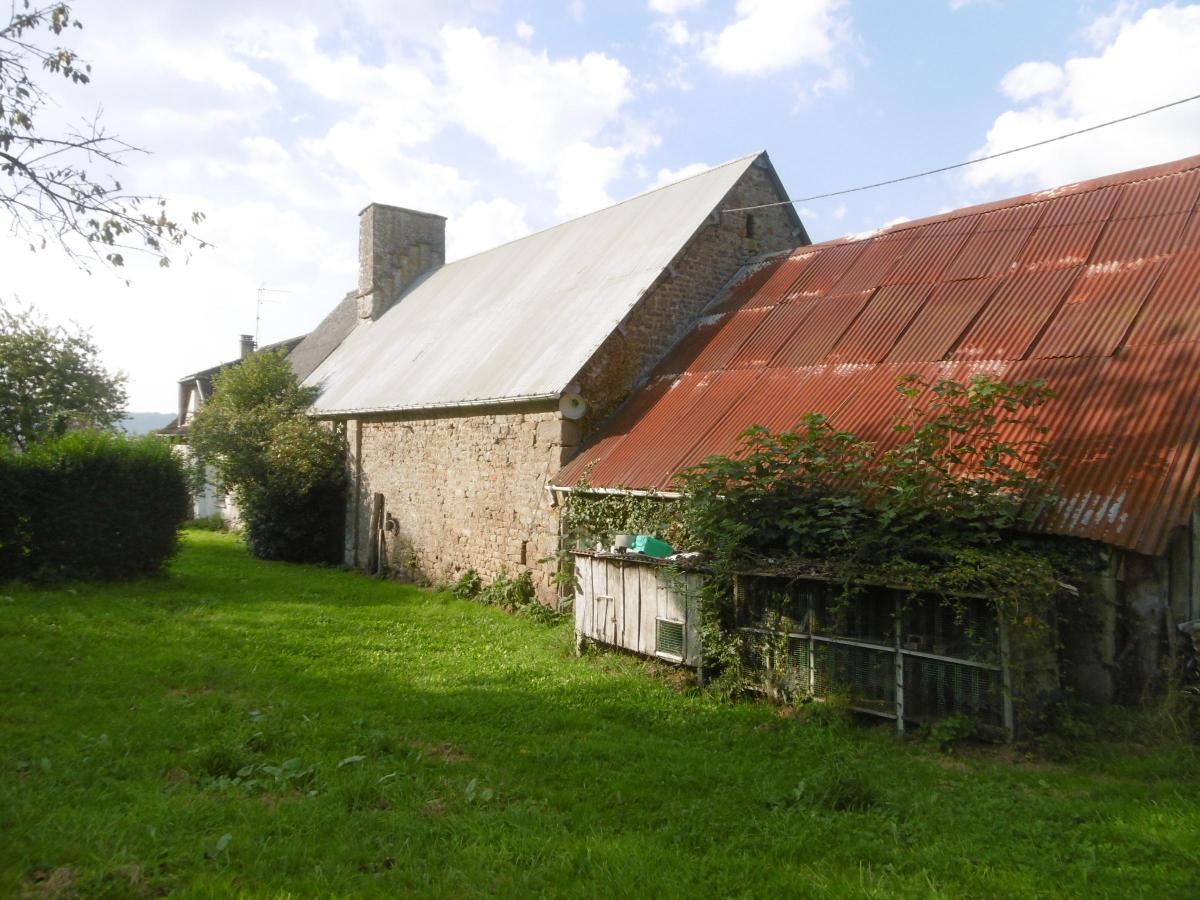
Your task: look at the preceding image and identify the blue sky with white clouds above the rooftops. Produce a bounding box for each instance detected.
[0,0,1200,409]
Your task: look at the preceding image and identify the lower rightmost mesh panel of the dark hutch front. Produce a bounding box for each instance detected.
[904,655,1004,725]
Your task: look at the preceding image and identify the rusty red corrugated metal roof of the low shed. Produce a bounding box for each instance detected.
[556,157,1200,553]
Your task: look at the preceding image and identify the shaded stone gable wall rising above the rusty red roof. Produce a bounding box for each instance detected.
[576,160,802,432]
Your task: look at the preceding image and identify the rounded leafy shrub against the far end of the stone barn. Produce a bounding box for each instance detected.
[188,353,346,562]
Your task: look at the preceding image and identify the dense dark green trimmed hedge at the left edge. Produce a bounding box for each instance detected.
[0,432,191,580]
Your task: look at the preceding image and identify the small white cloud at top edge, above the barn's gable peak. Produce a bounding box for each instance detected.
[703,0,850,86]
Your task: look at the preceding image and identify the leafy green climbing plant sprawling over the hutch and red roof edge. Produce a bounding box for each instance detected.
[556,376,1078,686]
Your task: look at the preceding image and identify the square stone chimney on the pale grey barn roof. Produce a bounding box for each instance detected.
[359,203,446,319]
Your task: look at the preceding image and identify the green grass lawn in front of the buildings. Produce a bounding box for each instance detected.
[0,532,1200,898]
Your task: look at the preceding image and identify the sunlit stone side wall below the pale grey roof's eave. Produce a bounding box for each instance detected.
[347,407,576,601]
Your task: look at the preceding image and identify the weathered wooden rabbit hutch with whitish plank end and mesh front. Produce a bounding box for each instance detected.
[575,552,1058,736]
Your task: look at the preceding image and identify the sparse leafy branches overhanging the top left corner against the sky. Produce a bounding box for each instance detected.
[0,0,203,269]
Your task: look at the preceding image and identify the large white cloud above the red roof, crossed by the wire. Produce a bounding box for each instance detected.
[965,5,1200,187]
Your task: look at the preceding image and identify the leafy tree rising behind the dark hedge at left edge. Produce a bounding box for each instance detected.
[0,305,126,450]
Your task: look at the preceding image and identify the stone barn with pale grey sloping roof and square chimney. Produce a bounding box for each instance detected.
[295,154,808,598]
